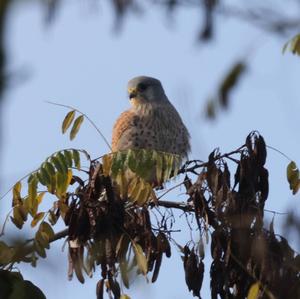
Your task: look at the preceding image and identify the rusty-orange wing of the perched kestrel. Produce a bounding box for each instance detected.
[112,110,138,152]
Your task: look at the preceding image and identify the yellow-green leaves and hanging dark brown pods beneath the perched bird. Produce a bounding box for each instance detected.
[0,125,300,299]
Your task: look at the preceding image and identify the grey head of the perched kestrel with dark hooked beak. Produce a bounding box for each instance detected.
[127,76,167,107]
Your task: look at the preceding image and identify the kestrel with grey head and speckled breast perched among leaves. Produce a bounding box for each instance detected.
[112,76,190,158]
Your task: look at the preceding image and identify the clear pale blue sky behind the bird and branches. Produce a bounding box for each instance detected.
[0,1,300,299]
